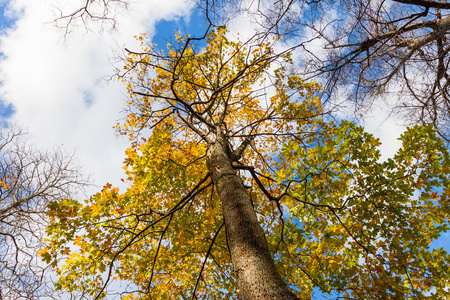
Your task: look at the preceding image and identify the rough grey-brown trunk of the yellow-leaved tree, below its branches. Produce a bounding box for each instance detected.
[206,132,298,300]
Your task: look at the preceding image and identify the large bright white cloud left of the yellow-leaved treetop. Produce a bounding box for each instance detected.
[0,0,191,196]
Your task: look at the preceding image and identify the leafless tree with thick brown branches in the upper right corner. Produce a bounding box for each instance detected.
[298,0,450,142]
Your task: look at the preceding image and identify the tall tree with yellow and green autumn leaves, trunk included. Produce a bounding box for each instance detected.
[41,28,450,299]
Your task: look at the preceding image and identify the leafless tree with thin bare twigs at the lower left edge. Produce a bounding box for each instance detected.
[0,128,85,299]
